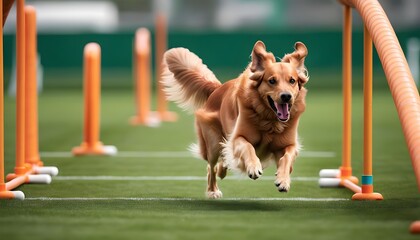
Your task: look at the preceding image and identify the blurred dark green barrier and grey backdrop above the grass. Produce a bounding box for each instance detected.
[4,0,420,88]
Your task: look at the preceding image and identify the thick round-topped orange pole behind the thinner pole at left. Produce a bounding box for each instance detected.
[25,6,43,166]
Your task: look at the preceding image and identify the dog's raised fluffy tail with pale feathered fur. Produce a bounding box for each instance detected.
[162,48,222,111]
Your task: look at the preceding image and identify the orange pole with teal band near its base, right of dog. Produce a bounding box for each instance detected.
[352,26,383,200]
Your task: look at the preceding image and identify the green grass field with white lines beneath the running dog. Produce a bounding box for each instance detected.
[0,83,420,240]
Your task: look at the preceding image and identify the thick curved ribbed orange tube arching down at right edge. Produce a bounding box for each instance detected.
[341,0,420,190]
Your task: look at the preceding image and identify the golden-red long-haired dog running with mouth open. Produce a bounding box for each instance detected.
[162,41,309,198]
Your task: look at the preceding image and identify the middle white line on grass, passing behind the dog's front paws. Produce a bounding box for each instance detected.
[53,176,319,182]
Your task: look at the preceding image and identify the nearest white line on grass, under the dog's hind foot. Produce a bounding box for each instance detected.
[25,197,349,202]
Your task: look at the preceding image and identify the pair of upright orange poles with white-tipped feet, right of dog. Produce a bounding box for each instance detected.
[319,21,383,200]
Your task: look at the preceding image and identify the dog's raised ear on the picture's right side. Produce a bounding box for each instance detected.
[281,42,309,88]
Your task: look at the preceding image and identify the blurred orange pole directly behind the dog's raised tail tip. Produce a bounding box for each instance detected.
[155,13,178,122]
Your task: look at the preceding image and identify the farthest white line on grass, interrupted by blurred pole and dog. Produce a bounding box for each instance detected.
[41,151,336,158]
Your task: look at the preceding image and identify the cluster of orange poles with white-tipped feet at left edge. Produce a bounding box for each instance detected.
[0,0,58,199]
